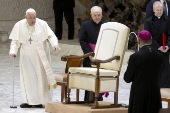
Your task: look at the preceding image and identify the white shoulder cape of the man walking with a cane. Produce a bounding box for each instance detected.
[9,18,54,43]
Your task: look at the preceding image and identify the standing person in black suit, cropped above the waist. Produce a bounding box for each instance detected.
[53,0,75,40]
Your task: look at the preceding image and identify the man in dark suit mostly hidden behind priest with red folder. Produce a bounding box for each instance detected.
[146,0,170,18]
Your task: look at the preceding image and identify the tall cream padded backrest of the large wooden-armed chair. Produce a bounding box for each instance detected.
[94,22,130,71]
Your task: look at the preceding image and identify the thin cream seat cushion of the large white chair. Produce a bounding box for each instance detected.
[69,67,118,76]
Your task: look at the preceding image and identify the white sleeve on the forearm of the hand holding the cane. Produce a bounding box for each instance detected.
[9,40,20,55]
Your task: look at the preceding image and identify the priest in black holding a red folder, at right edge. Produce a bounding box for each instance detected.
[144,1,170,88]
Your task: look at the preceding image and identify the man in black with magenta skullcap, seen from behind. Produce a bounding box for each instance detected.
[124,30,165,113]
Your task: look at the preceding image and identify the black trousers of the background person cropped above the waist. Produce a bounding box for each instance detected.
[54,6,74,40]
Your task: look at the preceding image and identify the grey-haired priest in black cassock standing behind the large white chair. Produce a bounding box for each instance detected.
[79,6,105,101]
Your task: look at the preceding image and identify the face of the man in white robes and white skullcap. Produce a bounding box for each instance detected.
[25,12,36,26]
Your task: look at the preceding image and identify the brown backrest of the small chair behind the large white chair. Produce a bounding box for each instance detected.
[65,55,84,73]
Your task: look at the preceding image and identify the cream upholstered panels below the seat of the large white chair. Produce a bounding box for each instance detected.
[69,73,117,93]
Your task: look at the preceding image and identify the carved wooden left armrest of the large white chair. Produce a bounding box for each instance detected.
[61,52,94,61]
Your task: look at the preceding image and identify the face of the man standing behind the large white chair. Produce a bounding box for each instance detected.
[91,10,102,24]
